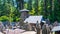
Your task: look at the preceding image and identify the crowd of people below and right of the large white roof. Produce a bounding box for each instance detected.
[23,19,60,34]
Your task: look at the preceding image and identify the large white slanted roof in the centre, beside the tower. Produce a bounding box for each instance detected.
[24,16,43,23]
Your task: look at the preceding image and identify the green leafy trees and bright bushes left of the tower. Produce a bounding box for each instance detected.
[0,0,20,22]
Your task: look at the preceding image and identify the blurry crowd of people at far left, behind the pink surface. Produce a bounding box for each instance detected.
[0,22,20,34]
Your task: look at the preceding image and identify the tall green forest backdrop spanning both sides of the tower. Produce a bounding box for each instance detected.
[0,0,60,22]
